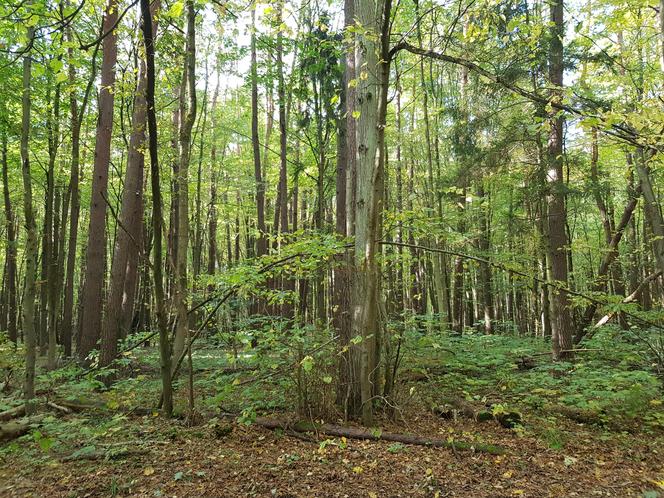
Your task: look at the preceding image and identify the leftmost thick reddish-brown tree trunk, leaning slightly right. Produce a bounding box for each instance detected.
[78,0,118,361]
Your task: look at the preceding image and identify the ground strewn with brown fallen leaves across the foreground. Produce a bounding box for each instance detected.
[0,408,664,498]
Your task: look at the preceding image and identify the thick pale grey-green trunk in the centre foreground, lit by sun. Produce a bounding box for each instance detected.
[352,0,391,425]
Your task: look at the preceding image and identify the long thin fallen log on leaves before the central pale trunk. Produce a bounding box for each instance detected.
[254,417,506,455]
